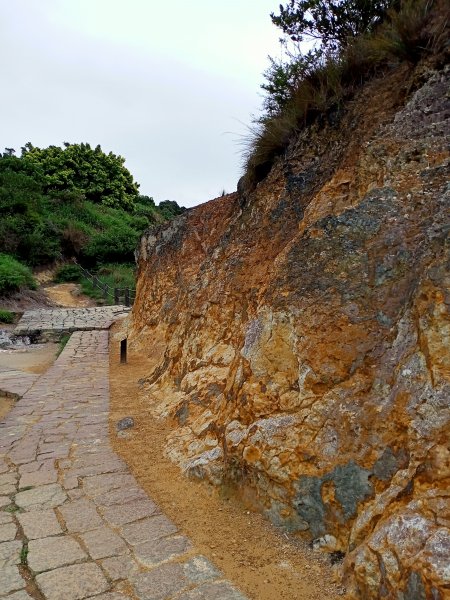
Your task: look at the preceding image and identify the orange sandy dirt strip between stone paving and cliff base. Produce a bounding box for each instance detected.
[110,325,340,600]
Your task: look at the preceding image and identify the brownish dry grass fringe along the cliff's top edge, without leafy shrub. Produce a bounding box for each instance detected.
[242,0,450,194]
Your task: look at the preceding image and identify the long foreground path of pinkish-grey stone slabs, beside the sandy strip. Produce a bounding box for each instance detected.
[0,328,244,600]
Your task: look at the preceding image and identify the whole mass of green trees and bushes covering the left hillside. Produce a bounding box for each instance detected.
[0,144,184,293]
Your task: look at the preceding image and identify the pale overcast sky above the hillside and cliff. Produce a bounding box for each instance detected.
[0,0,280,206]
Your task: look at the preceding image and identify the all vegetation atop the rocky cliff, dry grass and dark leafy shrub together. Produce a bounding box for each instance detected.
[243,0,450,191]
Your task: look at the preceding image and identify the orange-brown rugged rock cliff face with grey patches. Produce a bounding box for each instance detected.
[130,58,450,600]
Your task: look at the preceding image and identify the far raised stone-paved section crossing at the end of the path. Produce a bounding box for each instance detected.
[14,306,130,335]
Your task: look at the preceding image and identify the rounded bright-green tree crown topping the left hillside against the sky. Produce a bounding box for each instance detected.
[22,142,139,210]
